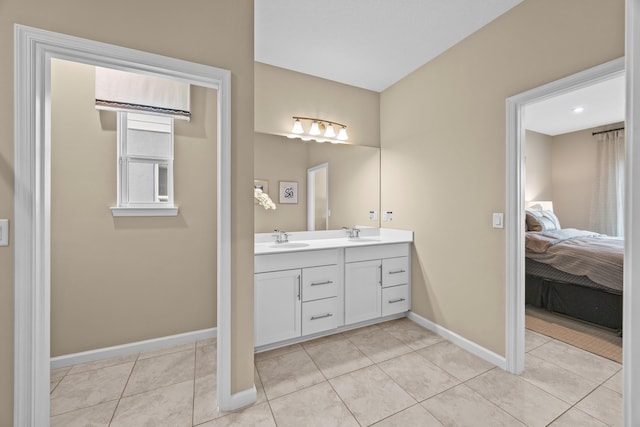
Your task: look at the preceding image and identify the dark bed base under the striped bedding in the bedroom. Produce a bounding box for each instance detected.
[525,274,622,332]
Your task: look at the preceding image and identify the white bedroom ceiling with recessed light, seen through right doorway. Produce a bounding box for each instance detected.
[524,76,625,136]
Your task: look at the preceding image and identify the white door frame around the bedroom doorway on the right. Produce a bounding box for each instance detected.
[505,57,630,375]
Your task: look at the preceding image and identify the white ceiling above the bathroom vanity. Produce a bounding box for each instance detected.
[254,0,522,92]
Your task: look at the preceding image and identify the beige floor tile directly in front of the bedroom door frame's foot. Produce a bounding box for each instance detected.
[465,368,571,427]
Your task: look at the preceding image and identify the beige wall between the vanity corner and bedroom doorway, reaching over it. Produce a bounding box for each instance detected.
[380,0,624,355]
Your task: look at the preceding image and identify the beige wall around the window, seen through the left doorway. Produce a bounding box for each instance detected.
[51,60,217,356]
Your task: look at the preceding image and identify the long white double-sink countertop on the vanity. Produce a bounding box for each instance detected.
[254,228,413,255]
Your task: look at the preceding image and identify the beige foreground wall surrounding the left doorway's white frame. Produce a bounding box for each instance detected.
[0,0,254,426]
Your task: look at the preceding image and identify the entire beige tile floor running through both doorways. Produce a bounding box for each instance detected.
[51,319,622,427]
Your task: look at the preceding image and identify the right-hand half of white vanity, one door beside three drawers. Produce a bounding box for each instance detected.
[344,243,410,325]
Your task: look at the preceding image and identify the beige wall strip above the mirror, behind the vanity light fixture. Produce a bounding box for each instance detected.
[255,62,380,147]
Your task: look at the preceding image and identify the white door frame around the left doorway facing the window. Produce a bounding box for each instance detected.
[13,25,236,427]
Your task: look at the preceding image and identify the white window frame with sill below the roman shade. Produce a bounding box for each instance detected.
[111,111,178,216]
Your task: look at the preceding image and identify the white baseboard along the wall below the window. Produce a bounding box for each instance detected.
[50,328,218,369]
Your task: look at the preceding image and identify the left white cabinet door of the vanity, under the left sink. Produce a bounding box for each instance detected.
[254,270,302,346]
